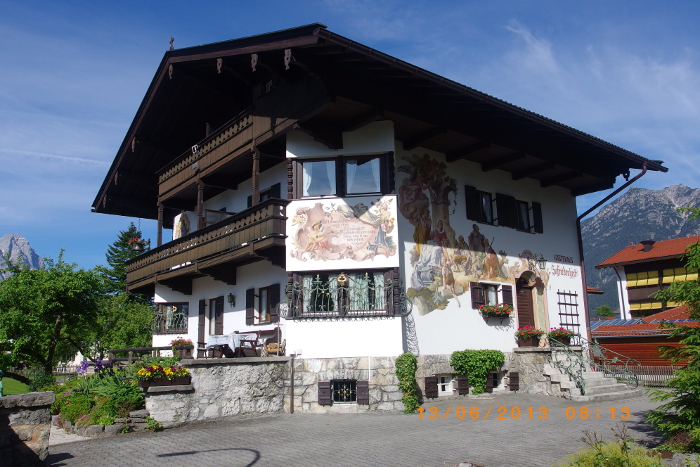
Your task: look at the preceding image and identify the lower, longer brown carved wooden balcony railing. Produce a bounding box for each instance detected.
[126,198,289,285]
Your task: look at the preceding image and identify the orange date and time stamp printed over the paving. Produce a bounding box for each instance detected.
[418,406,631,420]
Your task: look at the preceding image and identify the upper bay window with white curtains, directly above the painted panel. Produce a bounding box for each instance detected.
[300,154,390,196]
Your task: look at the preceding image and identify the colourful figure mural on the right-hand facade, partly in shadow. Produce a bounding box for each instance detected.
[398,154,549,315]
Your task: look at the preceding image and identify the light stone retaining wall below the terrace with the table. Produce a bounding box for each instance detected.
[146,357,290,426]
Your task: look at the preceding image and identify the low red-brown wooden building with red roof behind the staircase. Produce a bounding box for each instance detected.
[591,306,700,365]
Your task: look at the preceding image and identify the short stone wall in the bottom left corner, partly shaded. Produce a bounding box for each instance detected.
[0,392,56,467]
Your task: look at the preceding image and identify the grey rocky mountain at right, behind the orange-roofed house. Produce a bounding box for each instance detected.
[581,185,700,314]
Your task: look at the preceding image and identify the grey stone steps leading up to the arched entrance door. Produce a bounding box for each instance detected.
[544,363,644,402]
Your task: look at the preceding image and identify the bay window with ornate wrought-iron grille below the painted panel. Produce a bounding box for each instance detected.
[288,270,395,318]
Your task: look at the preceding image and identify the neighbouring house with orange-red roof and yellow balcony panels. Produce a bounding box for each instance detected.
[596,236,700,318]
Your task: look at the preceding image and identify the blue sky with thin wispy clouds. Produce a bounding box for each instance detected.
[0,0,700,268]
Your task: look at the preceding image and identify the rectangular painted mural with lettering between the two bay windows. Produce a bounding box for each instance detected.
[287,196,398,271]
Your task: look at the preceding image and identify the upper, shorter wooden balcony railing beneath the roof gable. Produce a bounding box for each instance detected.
[158,108,254,195]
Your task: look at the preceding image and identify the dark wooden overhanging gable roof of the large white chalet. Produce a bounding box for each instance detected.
[93,23,668,219]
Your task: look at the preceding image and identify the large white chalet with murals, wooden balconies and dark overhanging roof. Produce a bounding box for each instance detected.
[94,24,667,406]
